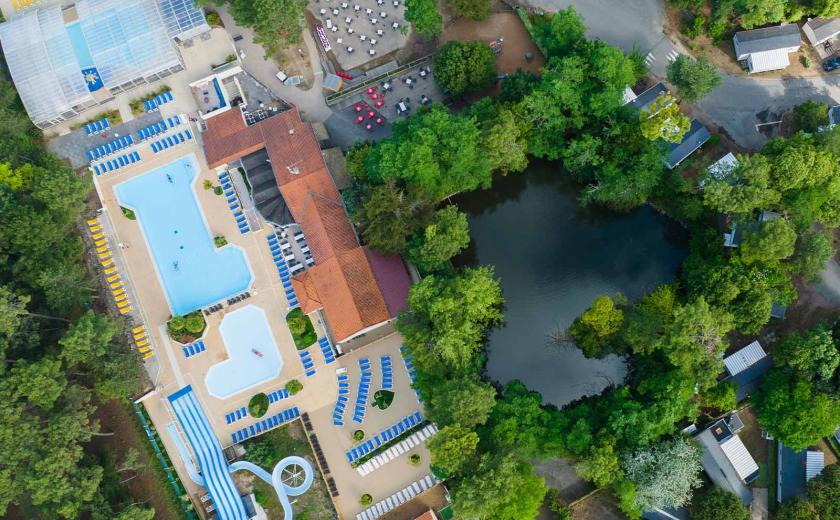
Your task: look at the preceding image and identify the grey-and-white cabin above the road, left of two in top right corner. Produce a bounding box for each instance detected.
[732,24,802,74]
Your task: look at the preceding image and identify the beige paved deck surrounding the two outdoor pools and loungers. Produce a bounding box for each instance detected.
[95,140,430,519]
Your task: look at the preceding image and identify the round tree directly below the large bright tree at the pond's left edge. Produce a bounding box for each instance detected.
[429,377,496,428]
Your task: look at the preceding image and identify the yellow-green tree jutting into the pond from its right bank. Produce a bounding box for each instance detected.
[569,295,624,357]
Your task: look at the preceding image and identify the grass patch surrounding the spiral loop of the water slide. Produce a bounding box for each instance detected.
[240,421,336,520]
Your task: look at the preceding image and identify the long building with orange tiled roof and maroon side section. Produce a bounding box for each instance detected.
[198,108,410,344]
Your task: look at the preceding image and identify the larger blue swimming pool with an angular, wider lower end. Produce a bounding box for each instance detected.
[116,154,253,316]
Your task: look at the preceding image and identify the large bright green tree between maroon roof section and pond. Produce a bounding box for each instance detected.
[397,267,504,369]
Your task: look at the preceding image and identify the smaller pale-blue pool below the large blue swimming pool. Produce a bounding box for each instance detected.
[204,305,283,399]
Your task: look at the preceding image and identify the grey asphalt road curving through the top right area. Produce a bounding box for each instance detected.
[528,0,840,149]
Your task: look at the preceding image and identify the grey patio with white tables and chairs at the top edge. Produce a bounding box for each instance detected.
[309,0,408,71]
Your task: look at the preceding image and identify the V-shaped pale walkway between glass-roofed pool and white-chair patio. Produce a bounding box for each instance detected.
[215,7,332,121]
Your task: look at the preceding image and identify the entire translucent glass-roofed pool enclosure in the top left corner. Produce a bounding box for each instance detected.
[0,0,210,128]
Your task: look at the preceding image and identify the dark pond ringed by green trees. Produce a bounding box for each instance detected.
[453,161,686,406]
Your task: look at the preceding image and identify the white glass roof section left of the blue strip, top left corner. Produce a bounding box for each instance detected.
[0,5,93,123]
